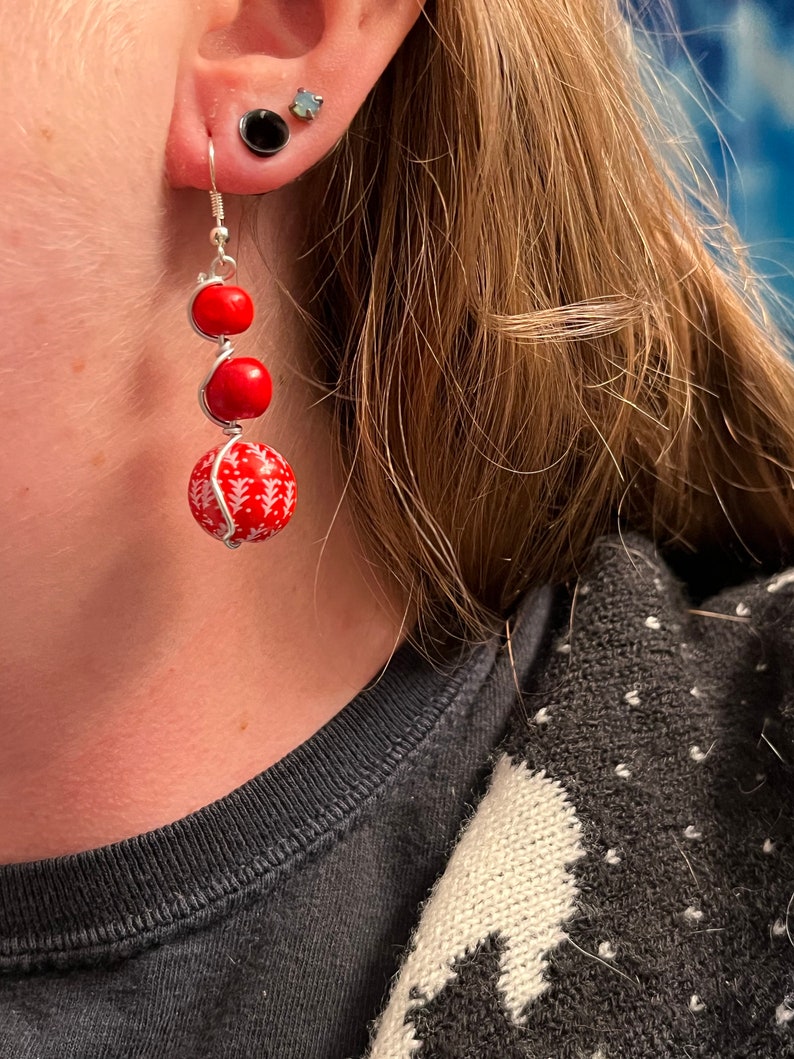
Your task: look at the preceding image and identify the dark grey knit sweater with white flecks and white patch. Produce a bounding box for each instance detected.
[369,538,794,1059]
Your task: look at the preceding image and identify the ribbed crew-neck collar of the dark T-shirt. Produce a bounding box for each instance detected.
[0,622,495,970]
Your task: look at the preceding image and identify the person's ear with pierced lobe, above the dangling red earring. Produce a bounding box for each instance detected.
[166,0,422,195]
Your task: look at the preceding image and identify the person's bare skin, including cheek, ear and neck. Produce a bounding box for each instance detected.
[0,0,419,863]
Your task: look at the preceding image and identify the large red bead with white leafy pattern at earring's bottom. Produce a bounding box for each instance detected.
[187,442,297,541]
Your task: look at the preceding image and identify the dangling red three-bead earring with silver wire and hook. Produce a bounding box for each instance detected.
[187,140,297,548]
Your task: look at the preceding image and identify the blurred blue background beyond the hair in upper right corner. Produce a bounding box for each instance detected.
[645,0,794,300]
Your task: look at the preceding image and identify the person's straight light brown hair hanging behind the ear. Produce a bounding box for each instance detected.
[302,0,794,646]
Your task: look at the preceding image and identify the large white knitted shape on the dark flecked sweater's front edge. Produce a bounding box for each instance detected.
[369,756,583,1059]
